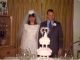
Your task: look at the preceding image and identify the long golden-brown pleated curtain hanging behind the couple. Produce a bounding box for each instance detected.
[8,0,73,49]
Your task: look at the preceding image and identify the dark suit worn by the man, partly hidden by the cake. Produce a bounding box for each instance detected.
[38,21,63,57]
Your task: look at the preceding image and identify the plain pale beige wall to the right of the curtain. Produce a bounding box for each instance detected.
[73,0,80,57]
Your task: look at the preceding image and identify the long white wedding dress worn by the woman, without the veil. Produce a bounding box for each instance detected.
[21,24,39,54]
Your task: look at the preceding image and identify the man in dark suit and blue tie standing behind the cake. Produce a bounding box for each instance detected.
[38,9,63,57]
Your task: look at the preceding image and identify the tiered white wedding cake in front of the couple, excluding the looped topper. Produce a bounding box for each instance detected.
[37,27,52,60]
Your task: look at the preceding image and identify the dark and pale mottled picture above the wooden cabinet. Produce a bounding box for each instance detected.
[0,0,8,15]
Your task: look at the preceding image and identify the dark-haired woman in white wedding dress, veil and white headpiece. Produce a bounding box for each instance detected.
[20,10,40,54]
